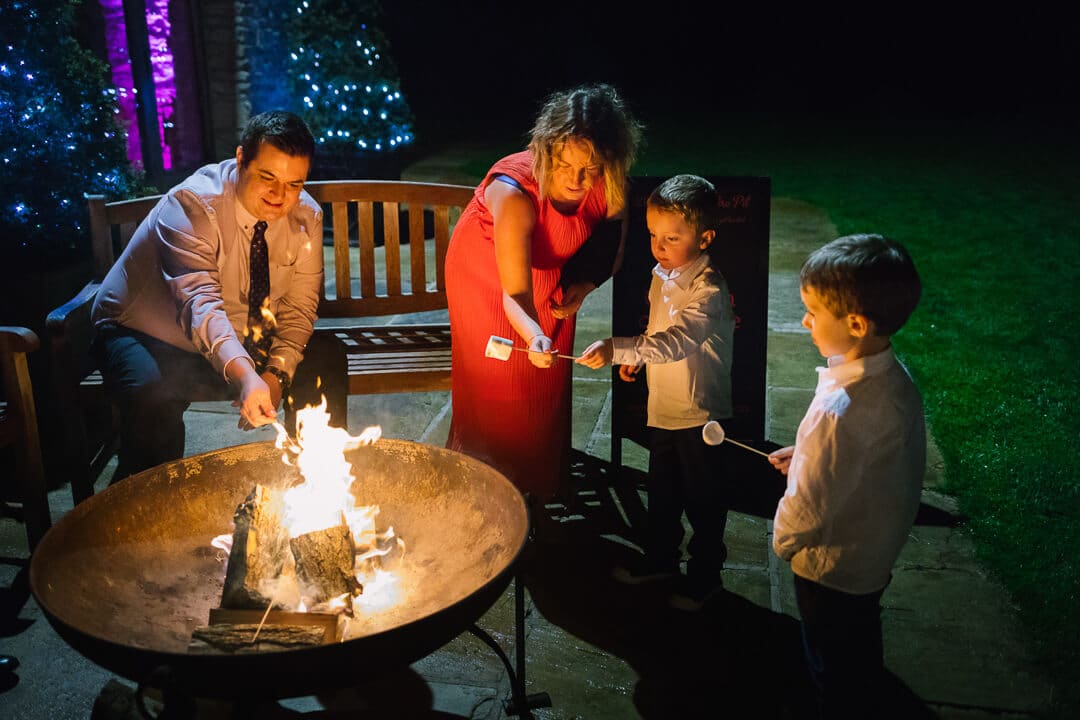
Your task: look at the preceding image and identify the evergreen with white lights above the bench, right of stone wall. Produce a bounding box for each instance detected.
[286,0,413,171]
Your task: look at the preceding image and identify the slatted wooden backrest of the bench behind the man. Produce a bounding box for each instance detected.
[86,180,474,317]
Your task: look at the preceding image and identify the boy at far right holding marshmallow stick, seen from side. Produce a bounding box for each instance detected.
[770,234,927,718]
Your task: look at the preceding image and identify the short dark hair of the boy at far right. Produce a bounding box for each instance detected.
[799,234,922,336]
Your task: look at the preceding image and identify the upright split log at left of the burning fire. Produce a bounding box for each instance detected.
[221,485,294,610]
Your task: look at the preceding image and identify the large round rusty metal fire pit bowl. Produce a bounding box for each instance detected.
[30,439,528,698]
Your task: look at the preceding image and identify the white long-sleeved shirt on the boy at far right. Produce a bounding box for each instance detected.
[772,348,927,595]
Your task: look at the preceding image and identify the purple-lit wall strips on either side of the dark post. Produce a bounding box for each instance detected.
[99,0,176,169]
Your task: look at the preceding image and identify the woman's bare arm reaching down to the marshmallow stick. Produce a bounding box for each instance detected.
[484,174,554,367]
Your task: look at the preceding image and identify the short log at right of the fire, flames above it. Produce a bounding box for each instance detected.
[288,518,364,603]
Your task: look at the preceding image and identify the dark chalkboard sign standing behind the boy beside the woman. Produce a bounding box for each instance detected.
[611,176,771,467]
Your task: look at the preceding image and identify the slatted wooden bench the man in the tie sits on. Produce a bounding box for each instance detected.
[46,180,474,502]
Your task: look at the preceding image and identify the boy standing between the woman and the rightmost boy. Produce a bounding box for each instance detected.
[577,175,735,611]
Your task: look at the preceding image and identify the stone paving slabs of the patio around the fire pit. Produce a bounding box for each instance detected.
[0,148,1053,720]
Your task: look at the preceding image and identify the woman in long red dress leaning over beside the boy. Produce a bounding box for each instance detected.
[446,84,640,502]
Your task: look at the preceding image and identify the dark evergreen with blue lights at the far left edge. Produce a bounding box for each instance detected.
[0,0,138,267]
